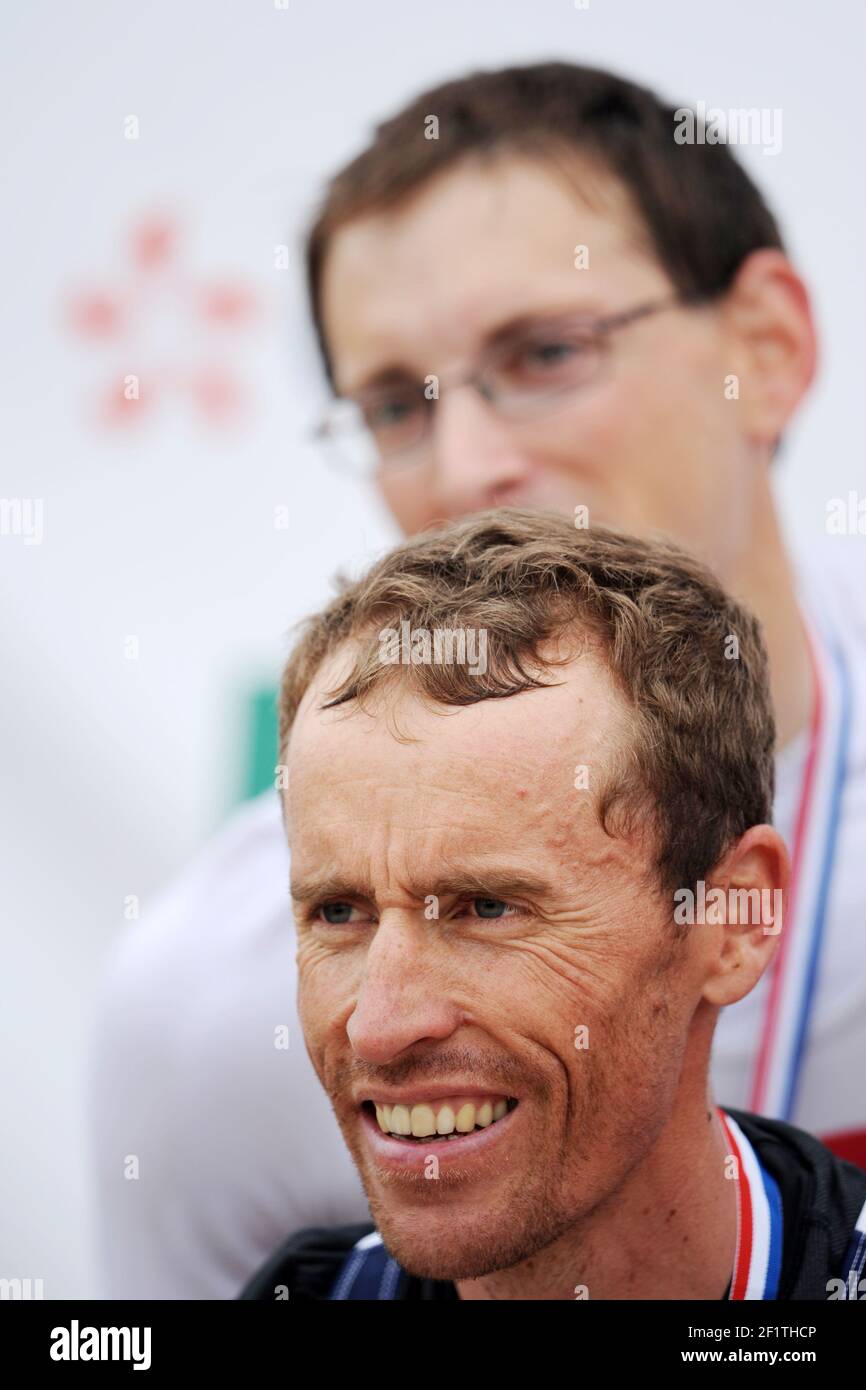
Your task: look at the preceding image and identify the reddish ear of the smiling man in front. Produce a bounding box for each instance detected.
[703,826,791,1008]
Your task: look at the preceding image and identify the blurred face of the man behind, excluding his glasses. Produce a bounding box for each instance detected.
[322,156,758,574]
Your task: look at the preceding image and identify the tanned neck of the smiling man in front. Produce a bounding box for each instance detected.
[456,1102,737,1300]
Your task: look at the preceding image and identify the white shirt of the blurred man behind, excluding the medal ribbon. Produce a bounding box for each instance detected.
[90,558,866,1298]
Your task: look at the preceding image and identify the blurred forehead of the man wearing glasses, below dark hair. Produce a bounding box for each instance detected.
[322,157,652,391]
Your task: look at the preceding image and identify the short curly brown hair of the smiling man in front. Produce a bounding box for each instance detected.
[279,507,776,890]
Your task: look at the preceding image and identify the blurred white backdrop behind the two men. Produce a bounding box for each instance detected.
[0,0,866,1298]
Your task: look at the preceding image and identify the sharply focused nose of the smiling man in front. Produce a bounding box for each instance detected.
[346,917,460,1066]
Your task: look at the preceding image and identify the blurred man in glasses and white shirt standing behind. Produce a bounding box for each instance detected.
[93,64,866,1298]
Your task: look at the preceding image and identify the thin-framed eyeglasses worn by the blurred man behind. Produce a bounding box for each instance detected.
[314,295,705,475]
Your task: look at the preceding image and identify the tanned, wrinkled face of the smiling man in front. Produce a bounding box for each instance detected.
[286,644,701,1297]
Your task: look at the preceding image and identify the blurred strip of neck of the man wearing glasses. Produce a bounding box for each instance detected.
[721,488,815,748]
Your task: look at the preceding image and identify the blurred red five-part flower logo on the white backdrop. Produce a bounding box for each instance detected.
[68,215,260,427]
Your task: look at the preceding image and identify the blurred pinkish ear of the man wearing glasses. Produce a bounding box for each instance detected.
[723,247,817,446]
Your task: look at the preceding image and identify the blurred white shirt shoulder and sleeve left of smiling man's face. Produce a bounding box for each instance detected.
[89,791,370,1298]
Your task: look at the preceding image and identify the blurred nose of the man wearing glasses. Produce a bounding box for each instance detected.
[431,385,530,518]
